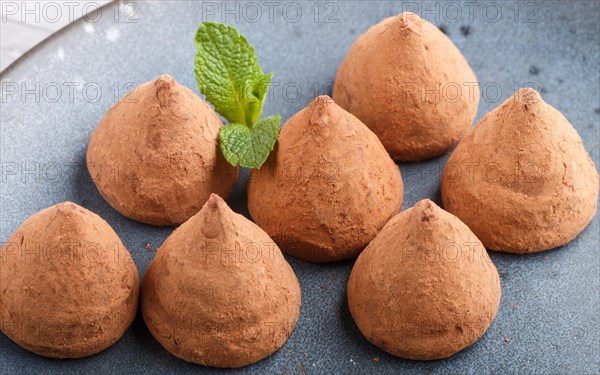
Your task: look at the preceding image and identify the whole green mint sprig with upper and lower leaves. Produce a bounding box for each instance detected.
[194,22,281,168]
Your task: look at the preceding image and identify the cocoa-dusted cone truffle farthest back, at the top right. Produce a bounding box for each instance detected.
[333,12,479,160]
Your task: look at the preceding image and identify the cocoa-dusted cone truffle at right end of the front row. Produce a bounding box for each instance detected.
[348,199,500,360]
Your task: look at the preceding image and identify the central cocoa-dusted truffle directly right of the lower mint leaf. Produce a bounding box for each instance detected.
[248,96,403,262]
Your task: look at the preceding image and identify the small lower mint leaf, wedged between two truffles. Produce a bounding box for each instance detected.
[219,115,281,168]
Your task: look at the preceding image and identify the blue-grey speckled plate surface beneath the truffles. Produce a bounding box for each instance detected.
[0,1,600,374]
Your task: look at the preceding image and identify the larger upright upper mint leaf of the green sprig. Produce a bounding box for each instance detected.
[194,22,273,127]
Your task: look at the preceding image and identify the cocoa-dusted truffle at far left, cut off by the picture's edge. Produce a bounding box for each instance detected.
[0,202,139,358]
